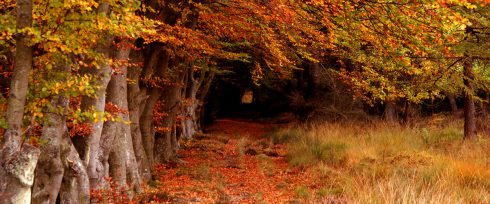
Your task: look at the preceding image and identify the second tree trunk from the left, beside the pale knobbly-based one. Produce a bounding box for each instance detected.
[32,65,70,203]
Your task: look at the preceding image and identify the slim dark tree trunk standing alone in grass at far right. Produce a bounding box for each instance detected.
[463,59,476,140]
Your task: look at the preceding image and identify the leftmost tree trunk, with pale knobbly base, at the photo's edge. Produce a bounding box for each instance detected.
[0,0,40,203]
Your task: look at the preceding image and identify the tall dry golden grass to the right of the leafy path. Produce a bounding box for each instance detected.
[271,120,490,203]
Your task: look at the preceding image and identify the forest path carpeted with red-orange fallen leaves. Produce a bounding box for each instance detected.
[150,119,319,203]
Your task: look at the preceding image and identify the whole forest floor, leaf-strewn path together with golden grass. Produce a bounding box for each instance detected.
[138,115,490,204]
